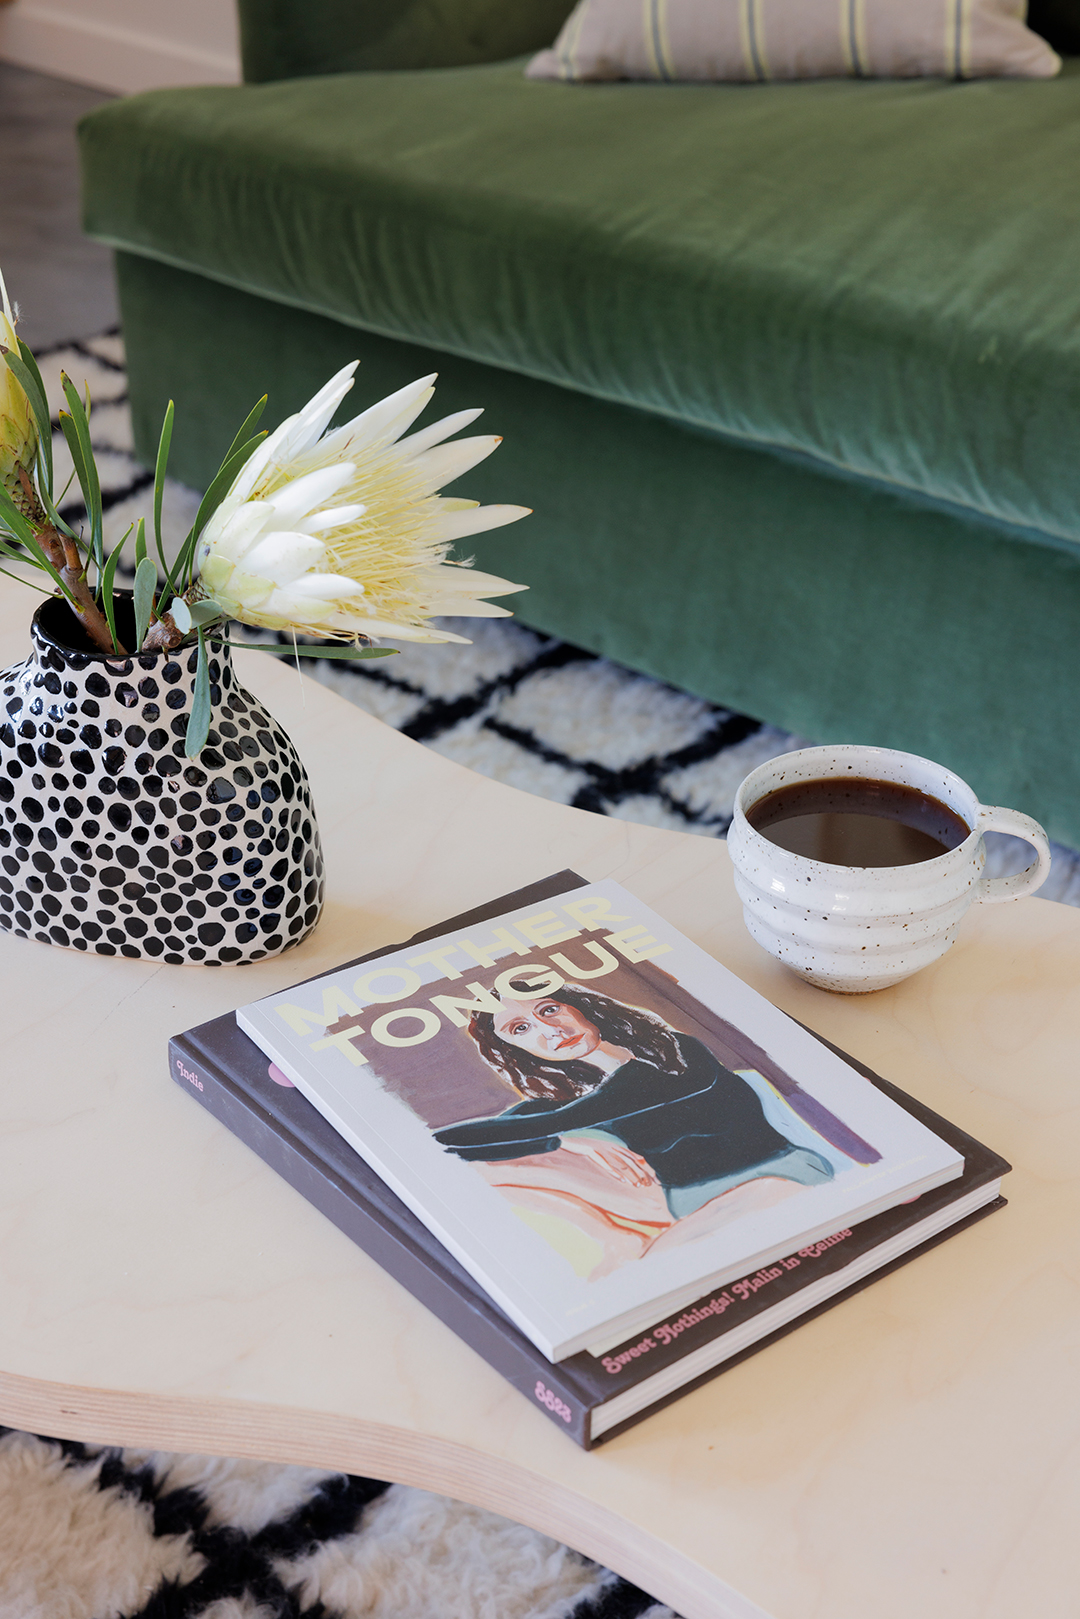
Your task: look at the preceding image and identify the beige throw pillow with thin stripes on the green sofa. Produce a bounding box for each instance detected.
[526,0,1061,81]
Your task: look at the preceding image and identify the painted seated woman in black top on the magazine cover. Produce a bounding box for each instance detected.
[436,984,852,1276]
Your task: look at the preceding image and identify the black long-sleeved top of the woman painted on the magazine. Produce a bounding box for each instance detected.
[436,1035,792,1187]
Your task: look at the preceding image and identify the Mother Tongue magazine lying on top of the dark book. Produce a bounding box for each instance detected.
[236,882,963,1360]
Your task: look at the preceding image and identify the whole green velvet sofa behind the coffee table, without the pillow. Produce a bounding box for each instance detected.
[81,0,1080,843]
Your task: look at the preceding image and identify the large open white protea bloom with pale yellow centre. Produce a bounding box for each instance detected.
[198,361,528,641]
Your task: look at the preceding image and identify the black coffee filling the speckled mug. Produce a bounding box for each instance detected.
[746,776,972,866]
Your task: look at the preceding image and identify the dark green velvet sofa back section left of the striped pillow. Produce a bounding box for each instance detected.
[238,0,573,83]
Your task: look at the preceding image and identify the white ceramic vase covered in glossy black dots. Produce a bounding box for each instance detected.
[0,593,322,967]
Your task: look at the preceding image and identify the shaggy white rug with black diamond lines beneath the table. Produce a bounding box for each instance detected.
[0,334,1080,1619]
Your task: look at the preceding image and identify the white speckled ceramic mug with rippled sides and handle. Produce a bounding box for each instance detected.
[727,746,1051,994]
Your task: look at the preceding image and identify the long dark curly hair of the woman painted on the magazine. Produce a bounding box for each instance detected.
[468,984,687,1103]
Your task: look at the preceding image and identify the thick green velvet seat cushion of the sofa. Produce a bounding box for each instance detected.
[81,62,1080,543]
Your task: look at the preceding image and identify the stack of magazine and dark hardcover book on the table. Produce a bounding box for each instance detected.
[170,871,1009,1447]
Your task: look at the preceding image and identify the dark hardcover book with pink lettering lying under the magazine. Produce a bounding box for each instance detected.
[170,871,1009,1449]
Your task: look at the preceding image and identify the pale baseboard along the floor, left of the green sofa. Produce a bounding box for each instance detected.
[0,0,240,94]
